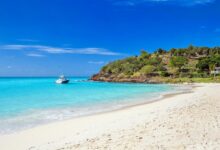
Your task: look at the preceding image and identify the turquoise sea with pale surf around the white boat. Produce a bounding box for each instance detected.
[0,78,189,134]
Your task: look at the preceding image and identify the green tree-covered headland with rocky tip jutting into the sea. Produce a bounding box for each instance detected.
[91,45,220,83]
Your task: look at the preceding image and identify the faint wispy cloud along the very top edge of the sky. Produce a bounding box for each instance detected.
[113,0,215,6]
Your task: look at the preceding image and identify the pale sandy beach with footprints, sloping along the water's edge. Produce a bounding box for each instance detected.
[0,84,220,150]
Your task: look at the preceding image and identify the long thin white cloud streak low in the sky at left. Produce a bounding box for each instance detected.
[0,45,120,55]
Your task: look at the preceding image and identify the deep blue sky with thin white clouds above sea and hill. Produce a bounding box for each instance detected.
[0,0,220,76]
